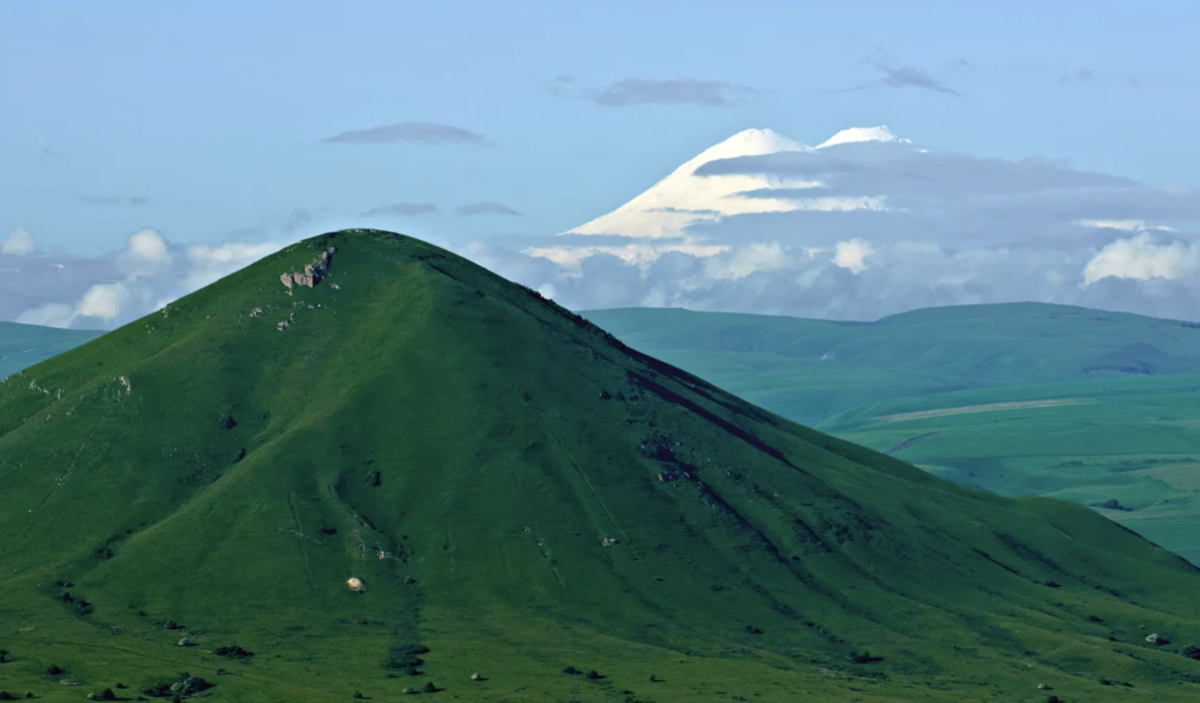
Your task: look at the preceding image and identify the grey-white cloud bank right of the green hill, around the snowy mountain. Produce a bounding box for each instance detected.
[455,130,1200,320]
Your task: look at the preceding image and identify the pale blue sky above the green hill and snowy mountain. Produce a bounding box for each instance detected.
[0,0,1200,325]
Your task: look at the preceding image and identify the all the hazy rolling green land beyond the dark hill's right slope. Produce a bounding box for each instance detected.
[587,304,1200,564]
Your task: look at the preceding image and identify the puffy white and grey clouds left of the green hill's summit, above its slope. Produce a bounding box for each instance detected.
[9,229,283,329]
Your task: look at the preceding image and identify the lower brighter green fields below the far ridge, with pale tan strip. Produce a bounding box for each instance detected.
[822,373,1200,564]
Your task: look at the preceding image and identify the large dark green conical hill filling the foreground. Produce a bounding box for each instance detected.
[0,230,1200,703]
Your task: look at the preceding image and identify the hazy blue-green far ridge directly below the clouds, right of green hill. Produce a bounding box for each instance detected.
[582,302,1200,423]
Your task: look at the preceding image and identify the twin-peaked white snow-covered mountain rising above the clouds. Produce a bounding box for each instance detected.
[526,126,911,263]
